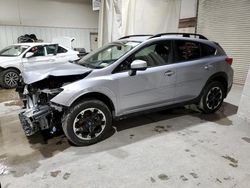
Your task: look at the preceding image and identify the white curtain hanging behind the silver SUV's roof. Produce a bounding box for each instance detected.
[98,0,181,46]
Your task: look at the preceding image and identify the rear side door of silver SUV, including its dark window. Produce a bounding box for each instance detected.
[174,40,215,102]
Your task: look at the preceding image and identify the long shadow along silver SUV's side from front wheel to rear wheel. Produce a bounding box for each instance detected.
[71,103,238,155]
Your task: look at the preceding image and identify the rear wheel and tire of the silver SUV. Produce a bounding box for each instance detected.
[199,81,226,114]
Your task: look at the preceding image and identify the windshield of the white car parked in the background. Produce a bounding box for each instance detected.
[0,45,29,57]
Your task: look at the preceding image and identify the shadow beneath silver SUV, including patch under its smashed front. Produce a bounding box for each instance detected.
[24,102,238,158]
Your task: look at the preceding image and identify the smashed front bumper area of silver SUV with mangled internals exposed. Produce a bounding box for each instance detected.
[19,86,62,136]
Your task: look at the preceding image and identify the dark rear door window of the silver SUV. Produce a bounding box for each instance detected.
[175,40,201,62]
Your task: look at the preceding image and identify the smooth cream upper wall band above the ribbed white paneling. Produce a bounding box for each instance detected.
[0,0,98,28]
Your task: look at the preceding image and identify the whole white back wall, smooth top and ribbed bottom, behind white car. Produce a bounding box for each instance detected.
[0,0,99,51]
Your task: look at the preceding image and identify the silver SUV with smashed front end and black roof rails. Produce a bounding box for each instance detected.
[17,33,233,146]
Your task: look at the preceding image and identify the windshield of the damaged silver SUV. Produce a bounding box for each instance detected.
[78,41,139,69]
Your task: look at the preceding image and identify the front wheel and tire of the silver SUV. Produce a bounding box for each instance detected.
[62,100,112,146]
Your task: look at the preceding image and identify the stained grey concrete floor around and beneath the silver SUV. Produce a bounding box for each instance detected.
[0,86,250,188]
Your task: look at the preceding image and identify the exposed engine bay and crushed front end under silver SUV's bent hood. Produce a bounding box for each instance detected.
[16,73,88,136]
